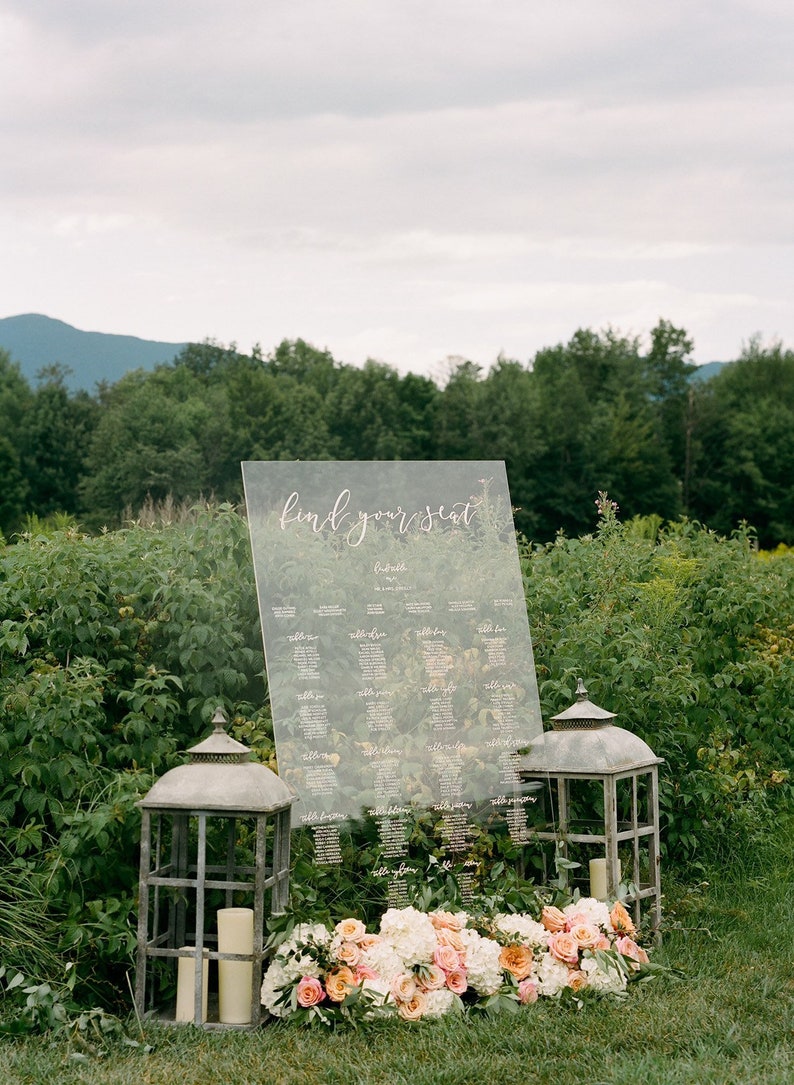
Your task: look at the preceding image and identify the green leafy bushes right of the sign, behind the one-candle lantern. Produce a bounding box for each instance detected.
[523,505,794,863]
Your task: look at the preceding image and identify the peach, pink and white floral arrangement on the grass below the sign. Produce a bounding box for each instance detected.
[261,897,650,1024]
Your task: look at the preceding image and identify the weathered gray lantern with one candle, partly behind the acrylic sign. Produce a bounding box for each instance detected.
[520,679,662,931]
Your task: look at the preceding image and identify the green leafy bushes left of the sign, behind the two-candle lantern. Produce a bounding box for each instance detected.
[0,508,265,998]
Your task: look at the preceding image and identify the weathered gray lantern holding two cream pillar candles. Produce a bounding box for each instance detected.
[136,709,295,1027]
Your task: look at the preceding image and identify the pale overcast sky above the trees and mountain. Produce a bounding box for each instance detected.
[0,0,794,375]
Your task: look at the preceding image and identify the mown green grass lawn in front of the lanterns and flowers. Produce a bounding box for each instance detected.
[0,842,794,1085]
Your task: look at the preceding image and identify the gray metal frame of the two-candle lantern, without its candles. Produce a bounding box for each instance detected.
[136,710,296,1029]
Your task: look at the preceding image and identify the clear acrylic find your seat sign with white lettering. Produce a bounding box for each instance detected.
[243,461,542,906]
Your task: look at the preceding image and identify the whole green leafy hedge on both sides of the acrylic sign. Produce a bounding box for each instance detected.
[0,497,794,1005]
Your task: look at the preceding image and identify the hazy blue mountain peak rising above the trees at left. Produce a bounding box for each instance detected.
[0,312,188,393]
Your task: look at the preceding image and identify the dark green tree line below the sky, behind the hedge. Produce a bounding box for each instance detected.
[0,320,794,546]
